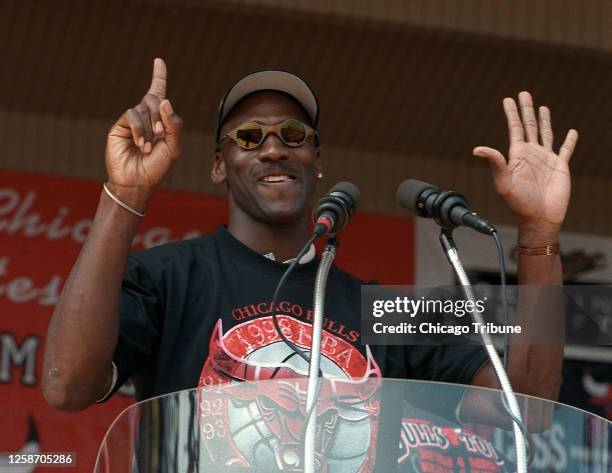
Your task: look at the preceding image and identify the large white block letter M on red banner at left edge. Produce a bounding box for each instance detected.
[0,333,40,386]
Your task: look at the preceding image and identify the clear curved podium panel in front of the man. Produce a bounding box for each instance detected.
[95,378,612,473]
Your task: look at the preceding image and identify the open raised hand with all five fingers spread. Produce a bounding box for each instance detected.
[473,92,578,240]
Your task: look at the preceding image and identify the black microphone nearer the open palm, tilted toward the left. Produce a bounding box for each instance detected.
[397,179,496,235]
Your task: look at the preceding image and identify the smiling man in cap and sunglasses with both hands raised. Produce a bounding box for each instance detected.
[43,59,577,410]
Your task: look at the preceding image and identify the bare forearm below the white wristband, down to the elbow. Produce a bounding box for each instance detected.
[42,188,146,410]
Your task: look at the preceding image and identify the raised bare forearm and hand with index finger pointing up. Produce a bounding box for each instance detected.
[42,59,182,411]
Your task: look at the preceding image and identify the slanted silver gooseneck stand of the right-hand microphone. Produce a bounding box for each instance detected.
[440,227,527,473]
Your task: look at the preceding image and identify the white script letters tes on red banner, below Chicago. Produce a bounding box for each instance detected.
[0,256,63,306]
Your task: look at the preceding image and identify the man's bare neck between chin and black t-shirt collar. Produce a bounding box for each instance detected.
[227,211,309,261]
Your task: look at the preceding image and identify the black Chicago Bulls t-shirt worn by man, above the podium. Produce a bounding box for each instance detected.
[114,227,486,400]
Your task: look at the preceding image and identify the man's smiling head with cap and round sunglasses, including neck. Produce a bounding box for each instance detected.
[211,88,322,261]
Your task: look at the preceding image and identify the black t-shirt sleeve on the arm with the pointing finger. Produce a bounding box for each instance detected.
[104,255,161,397]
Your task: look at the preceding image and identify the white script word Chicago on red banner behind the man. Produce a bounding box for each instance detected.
[0,188,202,248]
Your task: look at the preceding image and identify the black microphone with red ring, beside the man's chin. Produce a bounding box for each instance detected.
[312,181,361,237]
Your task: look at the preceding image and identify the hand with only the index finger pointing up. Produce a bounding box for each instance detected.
[106,58,182,211]
